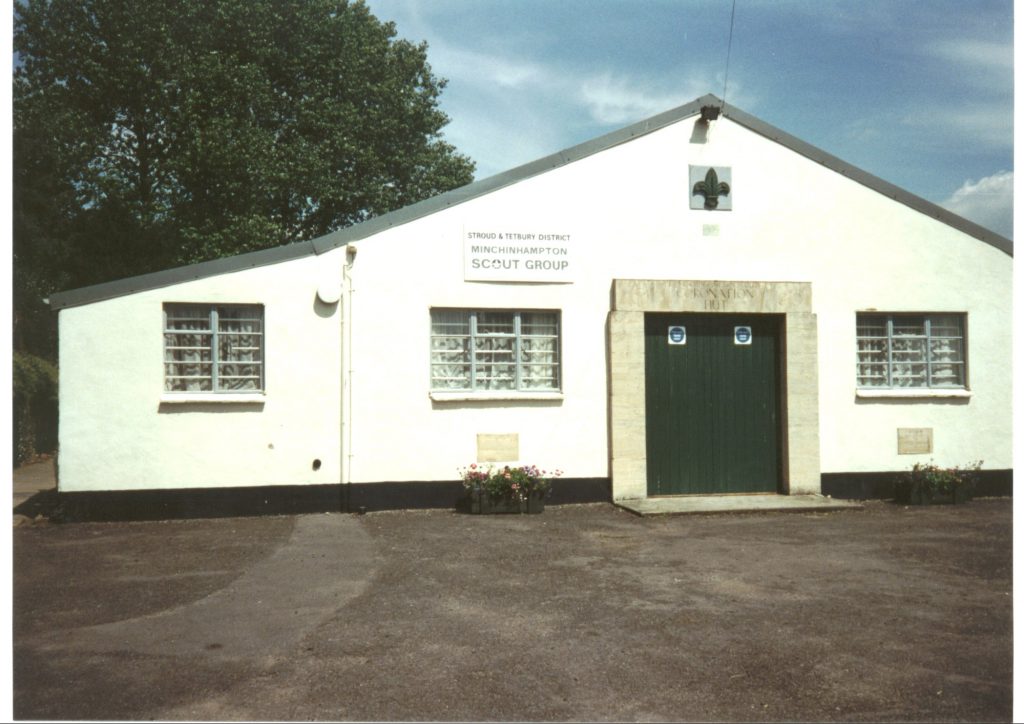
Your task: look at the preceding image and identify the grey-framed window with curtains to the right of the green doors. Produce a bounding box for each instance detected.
[857,314,967,388]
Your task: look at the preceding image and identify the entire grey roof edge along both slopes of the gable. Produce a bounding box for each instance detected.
[49,94,1013,310]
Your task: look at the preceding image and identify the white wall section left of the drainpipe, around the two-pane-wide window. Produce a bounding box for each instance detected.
[58,250,343,492]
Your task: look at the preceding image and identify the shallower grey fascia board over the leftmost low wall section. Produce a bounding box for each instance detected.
[50,242,313,311]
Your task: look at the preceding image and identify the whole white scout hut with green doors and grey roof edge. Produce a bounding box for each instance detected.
[51,95,1013,507]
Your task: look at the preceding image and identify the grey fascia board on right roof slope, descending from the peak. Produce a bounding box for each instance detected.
[722,101,1014,256]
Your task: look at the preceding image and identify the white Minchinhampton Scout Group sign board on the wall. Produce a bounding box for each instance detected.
[463,227,575,284]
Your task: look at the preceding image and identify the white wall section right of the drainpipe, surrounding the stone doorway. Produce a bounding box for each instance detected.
[342,120,1012,482]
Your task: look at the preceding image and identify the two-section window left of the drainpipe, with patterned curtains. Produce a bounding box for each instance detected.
[164,304,263,392]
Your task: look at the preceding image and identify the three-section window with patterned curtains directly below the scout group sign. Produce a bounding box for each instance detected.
[430,309,560,392]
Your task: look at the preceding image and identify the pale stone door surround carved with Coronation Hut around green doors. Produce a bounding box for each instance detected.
[608,280,821,500]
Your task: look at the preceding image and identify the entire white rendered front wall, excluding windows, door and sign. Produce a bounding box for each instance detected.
[59,101,1013,492]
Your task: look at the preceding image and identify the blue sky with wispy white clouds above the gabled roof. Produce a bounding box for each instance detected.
[368,0,1014,237]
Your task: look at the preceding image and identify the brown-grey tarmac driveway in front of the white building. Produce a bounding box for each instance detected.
[13,499,1013,721]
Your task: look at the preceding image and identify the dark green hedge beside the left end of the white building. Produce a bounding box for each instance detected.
[11,352,57,465]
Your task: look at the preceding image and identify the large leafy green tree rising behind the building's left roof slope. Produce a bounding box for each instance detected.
[13,0,473,356]
